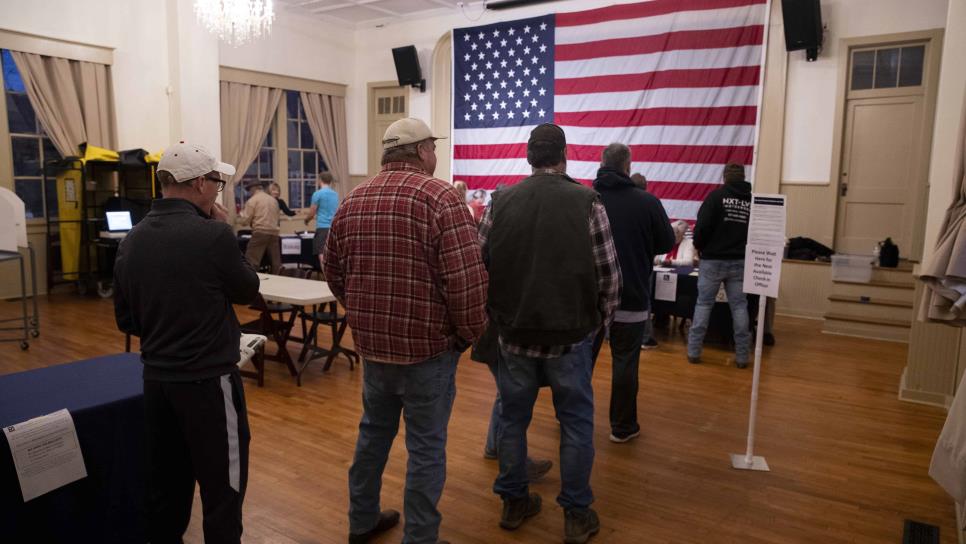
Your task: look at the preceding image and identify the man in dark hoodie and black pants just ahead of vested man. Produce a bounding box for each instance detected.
[594,143,674,443]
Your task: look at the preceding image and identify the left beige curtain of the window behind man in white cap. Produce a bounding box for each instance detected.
[221,81,285,218]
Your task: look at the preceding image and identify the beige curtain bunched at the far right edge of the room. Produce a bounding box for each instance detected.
[919,90,966,326]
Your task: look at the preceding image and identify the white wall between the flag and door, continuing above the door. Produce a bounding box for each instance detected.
[782,0,948,183]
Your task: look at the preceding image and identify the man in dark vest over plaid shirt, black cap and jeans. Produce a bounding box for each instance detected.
[480,123,620,544]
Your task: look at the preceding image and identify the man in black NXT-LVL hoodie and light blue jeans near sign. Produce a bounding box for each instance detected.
[688,159,751,368]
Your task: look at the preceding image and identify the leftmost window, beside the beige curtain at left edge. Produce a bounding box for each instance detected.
[0,49,61,219]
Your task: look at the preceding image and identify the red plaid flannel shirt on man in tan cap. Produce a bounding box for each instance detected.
[323,162,487,364]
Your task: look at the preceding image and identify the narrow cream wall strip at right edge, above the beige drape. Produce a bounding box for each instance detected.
[923,0,966,260]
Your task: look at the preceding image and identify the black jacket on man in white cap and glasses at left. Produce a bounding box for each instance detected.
[114,198,258,381]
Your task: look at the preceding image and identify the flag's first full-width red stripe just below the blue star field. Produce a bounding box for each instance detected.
[453,143,753,164]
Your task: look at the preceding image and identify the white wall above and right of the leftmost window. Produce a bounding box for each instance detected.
[0,0,169,150]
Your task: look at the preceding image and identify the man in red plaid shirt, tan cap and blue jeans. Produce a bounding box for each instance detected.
[323,118,487,544]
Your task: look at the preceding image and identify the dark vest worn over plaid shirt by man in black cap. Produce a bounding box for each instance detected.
[487,174,601,346]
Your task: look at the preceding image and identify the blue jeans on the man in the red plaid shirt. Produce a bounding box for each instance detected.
[349,351,459,544]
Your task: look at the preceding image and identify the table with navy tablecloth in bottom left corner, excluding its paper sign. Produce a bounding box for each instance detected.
[0,353,144,544]
